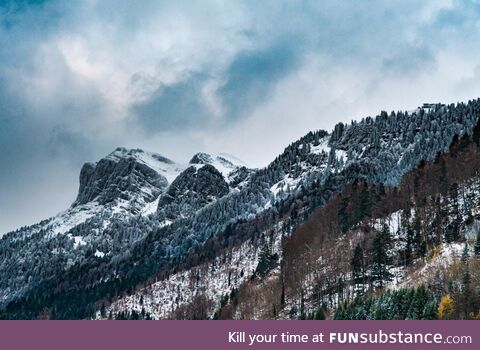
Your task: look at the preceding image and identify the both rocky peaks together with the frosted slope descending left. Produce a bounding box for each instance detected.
[0,147,252,303]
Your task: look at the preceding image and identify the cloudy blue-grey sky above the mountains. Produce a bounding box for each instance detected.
[0,0,480,233]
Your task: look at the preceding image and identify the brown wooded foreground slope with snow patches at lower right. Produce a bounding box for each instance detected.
[112,112,480,319]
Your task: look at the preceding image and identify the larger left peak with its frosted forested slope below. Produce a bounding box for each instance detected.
[0,148,248,304]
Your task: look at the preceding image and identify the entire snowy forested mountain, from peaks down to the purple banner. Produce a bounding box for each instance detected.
[0,100,480,319]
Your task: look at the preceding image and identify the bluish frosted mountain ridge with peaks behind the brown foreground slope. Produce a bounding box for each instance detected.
[0,100,480,318]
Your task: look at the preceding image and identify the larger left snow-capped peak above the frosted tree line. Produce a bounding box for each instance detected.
[51,147,186,234]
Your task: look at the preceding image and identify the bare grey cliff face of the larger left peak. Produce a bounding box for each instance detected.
[73,148,173,211]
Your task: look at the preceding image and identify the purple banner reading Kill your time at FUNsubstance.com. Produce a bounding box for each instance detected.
[0,321,480,350]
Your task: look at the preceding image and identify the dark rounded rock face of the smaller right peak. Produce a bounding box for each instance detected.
[158,164,229,220]
